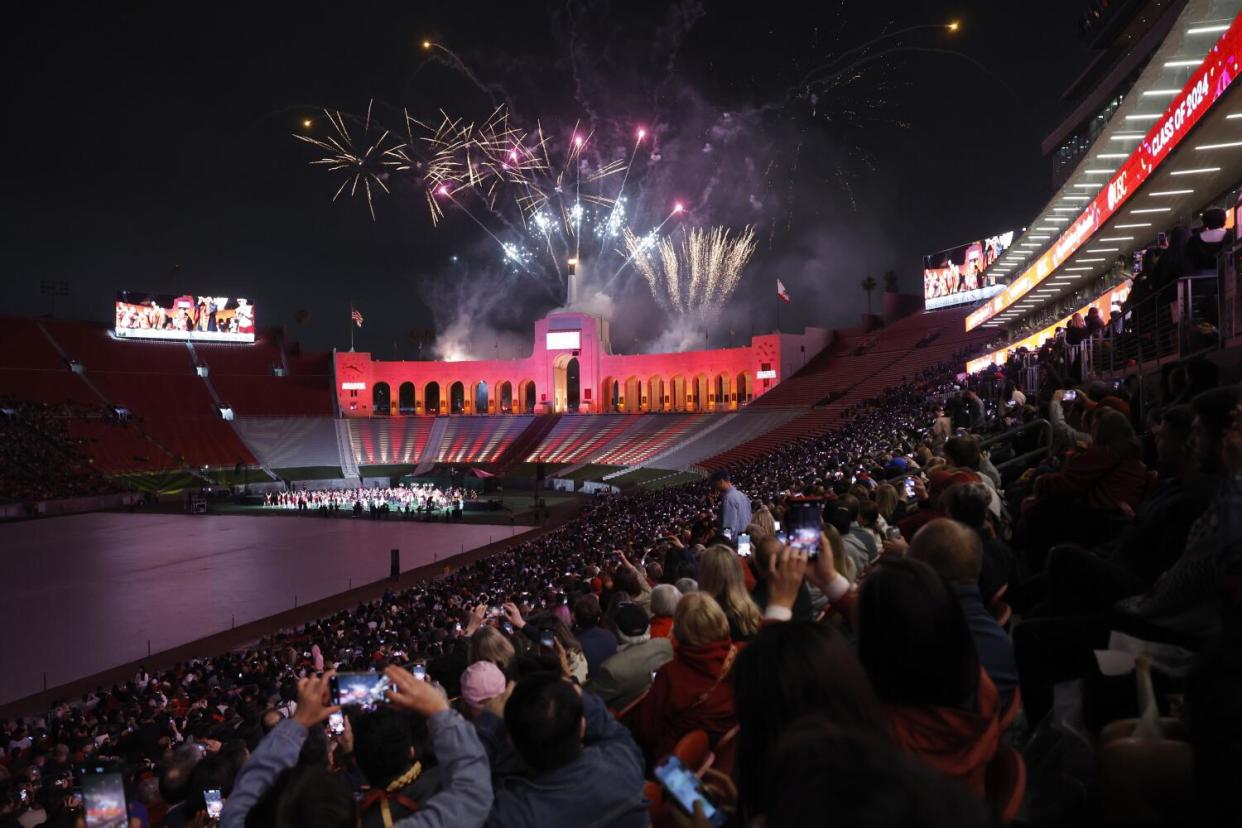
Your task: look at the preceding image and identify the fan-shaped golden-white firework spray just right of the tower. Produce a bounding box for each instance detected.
[625,226,755,317]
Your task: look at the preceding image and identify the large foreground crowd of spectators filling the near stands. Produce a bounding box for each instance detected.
[0,352,1242,828]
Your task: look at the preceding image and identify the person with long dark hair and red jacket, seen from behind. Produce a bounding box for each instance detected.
[858,556,1000,797]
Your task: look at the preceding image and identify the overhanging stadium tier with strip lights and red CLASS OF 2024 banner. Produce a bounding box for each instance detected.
[966,0,1242,330]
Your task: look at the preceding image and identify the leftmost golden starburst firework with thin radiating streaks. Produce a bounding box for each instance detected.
[293,104,412,221]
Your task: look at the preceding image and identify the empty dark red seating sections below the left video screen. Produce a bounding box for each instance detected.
[0,319,338,473]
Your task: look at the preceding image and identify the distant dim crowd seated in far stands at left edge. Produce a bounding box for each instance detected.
[0,397,116,503]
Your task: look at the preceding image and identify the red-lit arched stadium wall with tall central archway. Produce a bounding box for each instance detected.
[334,312,831,417]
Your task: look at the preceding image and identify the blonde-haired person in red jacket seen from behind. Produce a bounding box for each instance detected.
[635,592,740,761]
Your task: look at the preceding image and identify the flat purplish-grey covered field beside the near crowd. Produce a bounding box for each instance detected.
[0,513,529,704]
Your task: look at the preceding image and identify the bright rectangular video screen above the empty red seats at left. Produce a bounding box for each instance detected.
[114,290,255,343]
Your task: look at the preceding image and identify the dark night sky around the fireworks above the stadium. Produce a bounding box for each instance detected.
[9,0,1092,358]
